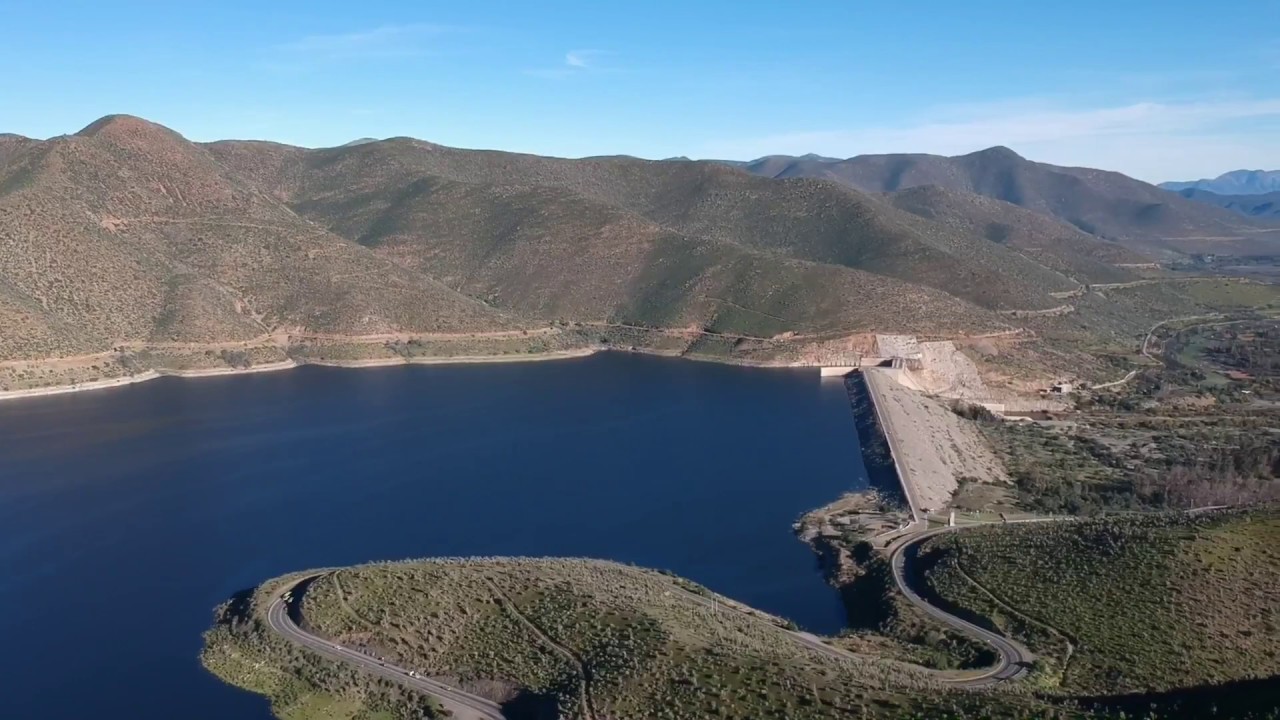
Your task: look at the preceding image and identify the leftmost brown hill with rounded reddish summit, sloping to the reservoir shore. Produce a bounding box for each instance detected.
[0,117,515,357]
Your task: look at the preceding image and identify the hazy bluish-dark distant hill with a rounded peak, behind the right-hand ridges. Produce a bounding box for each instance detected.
[746,147,1280,252]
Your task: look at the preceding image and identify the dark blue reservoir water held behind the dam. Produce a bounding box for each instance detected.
[0,354,865,720]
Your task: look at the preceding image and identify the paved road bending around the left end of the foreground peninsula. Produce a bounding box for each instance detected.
[266,575,503,720]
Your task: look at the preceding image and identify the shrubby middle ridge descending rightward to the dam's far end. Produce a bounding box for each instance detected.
[282,169,997,337]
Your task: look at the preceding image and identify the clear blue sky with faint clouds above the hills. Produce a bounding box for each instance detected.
[0,0,1280,181]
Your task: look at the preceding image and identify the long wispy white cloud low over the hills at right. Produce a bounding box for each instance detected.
[705,99,1280,179]
